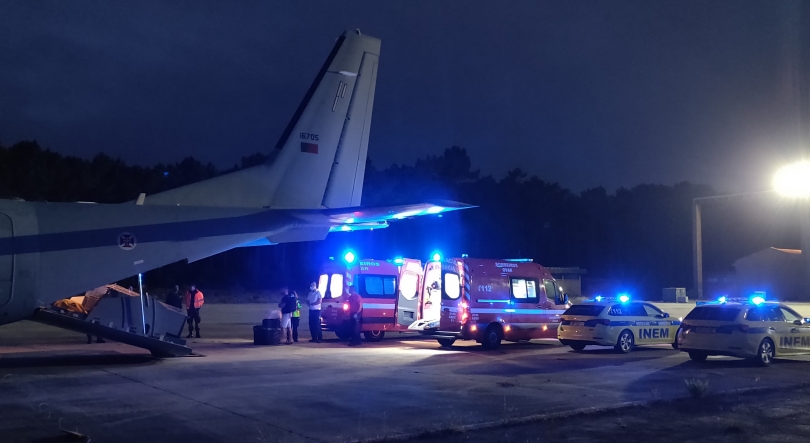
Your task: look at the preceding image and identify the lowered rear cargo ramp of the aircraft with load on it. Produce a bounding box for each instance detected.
[32,285,191,357]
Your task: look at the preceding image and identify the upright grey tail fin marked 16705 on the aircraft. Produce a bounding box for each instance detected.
[144,31,380,209]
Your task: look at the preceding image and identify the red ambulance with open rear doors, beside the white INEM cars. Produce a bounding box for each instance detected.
[410,254,569,349]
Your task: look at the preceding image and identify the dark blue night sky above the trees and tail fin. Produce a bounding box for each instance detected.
[0,0,810,192]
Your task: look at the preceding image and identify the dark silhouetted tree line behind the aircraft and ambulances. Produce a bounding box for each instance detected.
[0,141,798,299]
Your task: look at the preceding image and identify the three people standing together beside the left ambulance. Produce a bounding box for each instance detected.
[278,282,363,346]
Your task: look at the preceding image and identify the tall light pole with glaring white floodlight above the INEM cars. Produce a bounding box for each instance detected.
[692,161,810,300]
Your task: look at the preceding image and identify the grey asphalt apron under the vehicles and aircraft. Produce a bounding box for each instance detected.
[0,305,810,442]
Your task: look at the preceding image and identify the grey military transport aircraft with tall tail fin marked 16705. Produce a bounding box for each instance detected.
[0,31,467,325]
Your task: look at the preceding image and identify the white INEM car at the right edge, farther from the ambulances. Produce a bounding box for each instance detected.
[678,297,810,366]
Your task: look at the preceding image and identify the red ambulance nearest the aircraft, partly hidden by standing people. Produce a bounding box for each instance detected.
[318,251,422,341]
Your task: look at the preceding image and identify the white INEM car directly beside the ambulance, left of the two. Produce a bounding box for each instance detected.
[557,295,681,353]
